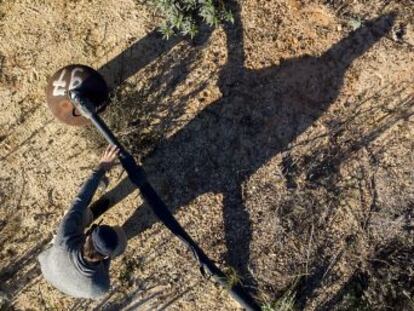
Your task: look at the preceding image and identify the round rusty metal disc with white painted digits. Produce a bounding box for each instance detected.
[46,65,108,126]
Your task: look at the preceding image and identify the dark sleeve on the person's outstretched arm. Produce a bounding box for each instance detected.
[54,169,105,246]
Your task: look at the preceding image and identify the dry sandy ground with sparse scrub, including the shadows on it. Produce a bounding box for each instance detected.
[0,0,414,310]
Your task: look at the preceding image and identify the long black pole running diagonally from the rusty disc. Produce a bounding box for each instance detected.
[70,92,261,311]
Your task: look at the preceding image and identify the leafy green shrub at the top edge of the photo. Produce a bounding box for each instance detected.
[149,0,234,39]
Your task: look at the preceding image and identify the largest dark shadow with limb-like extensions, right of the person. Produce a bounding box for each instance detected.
[90,3,394,292]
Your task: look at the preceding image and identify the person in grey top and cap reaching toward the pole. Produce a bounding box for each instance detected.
[38,145,127,299]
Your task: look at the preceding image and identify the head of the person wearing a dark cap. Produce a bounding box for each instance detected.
[82,225,125,262]
